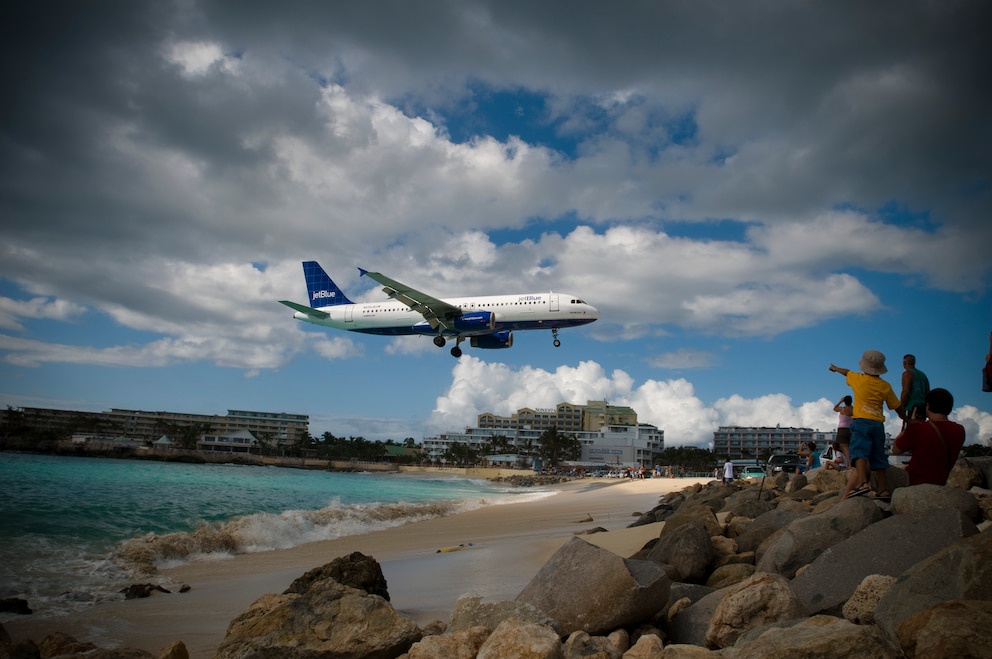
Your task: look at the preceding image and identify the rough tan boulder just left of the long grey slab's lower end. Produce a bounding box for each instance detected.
[704,572,808,649]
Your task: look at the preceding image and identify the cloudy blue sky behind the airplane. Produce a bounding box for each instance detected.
[0,0,992,447]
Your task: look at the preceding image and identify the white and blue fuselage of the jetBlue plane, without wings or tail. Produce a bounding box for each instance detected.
[294,292,599,336]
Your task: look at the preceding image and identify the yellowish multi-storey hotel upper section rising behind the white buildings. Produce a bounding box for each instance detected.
[477,400,637,434]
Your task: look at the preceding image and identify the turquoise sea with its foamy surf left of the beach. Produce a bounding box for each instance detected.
[0,452,551,621]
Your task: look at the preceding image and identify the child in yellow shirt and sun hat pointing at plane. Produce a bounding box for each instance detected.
[830,350,906,499]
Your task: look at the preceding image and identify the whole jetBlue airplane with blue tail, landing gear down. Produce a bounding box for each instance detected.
[279,261,599,358]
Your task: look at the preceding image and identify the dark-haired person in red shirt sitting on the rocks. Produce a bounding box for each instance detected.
[892,388,964,485]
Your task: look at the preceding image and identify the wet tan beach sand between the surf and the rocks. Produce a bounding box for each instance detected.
[4,478,706,659]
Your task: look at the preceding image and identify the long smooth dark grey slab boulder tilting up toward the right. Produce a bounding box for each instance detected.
[792,510,978,615]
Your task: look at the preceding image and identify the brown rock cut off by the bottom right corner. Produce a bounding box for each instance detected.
[897,600,992,659]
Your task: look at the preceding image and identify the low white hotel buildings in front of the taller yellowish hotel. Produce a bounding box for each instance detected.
[423,423,665,469]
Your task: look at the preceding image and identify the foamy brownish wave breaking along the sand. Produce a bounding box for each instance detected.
[112,499,466,574]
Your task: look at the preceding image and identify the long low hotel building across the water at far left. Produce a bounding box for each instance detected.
[0,407,310,446]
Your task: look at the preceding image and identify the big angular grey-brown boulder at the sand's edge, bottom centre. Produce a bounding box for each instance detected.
[516,537,671,636]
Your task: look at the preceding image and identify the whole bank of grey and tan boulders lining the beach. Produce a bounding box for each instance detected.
[0,458,992,659]
